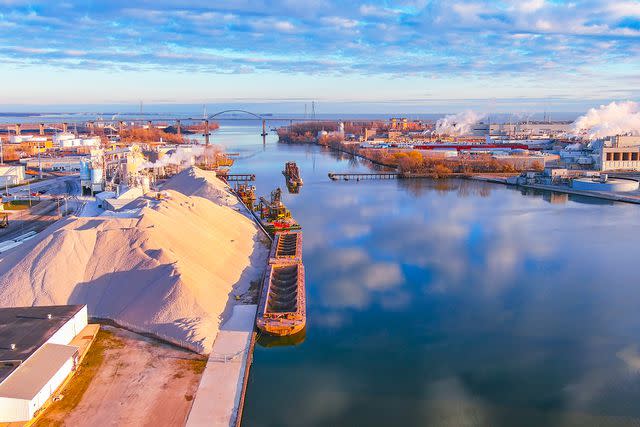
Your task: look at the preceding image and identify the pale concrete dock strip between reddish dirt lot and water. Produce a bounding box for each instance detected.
[187,305,258,427]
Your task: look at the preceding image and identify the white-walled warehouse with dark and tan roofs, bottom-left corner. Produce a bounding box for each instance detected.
[0,305,87,422]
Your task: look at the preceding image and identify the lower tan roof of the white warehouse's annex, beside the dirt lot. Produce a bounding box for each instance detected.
[0,344,78,400]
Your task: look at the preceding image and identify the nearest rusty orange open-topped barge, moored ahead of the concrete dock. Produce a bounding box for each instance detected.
[256,262,307,336]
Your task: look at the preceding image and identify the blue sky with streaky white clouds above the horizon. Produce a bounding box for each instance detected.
[0,0,640,113]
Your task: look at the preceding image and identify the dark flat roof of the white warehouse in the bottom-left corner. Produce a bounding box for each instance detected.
[0,305,84,381]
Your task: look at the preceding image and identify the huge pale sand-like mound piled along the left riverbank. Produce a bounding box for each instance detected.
[0,169,267,353]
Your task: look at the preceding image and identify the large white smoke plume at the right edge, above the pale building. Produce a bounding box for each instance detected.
[573,101,640,140]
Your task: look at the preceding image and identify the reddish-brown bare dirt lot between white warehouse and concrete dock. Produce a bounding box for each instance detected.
[35,326,206,427]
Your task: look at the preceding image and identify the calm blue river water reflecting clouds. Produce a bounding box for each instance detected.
[226,126,640,426]
